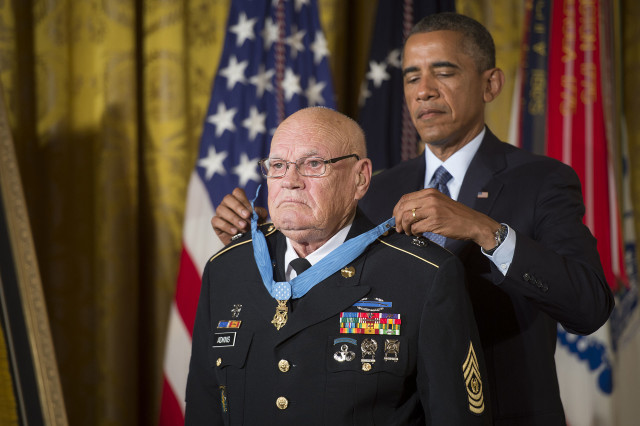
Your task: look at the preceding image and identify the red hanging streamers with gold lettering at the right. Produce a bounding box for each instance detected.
[547,1,627,291]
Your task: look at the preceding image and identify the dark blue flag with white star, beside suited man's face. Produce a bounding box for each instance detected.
[358,0,455,170]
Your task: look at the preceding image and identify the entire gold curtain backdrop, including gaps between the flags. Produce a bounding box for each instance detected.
[0,0,640,425]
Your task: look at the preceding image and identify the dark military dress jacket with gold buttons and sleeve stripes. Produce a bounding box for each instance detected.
[186,211,491,426]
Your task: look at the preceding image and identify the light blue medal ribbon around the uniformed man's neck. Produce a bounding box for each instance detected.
[251,187,395,300]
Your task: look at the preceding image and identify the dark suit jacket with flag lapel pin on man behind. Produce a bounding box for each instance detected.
[360,129,614,426]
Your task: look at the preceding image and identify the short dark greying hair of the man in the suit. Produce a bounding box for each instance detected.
[403,12,496,72]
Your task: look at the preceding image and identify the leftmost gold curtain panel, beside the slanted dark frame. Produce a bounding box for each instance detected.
[25,0,142,425]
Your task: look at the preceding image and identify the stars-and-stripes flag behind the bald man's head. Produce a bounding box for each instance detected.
[160,0,335,426]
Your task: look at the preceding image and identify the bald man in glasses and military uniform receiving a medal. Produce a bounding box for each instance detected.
[186,108,491,425]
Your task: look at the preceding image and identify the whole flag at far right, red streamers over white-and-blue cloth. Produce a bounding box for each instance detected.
[511,0,640,426]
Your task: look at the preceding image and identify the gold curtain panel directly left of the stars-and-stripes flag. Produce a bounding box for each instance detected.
[140,0,230,424]
